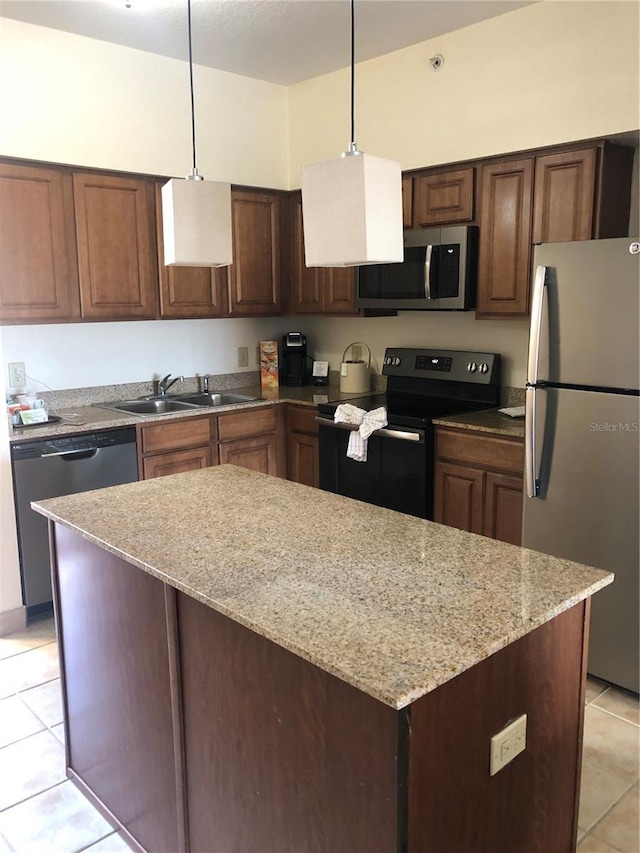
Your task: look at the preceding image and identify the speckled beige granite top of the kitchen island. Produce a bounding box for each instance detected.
[33,465,613,708]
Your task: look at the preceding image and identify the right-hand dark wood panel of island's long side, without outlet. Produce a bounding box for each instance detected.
[178,593,398,853]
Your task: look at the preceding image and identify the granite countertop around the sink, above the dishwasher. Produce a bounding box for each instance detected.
[9,385,364,443]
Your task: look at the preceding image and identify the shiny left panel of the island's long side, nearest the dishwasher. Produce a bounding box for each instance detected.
[53,525,185,853]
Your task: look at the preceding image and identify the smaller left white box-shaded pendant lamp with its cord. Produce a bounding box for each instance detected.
[162,0,233,267]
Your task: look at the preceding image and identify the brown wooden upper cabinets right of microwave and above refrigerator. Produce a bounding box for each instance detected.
[476,141,633,318]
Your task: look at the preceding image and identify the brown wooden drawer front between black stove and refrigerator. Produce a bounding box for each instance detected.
[436,428,524,475]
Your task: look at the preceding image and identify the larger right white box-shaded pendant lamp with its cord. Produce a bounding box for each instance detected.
[302,0,404,267]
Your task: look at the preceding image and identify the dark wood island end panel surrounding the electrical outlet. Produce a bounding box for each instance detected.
[408,602,589,853]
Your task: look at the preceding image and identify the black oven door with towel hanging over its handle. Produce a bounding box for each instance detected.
[316,417,433,519]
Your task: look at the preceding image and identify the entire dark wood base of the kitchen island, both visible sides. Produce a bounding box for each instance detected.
[52,525,589,853]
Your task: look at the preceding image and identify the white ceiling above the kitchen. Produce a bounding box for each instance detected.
[0,0,536,85]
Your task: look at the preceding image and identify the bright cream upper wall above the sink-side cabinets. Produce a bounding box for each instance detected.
[0,18,288,188]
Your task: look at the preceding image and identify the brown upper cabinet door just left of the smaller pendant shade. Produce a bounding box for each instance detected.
[73,173,158,319]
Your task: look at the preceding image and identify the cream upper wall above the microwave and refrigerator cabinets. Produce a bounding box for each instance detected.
[289,0,640,178]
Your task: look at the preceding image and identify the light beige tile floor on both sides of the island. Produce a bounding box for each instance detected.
[0,619,640,853]
